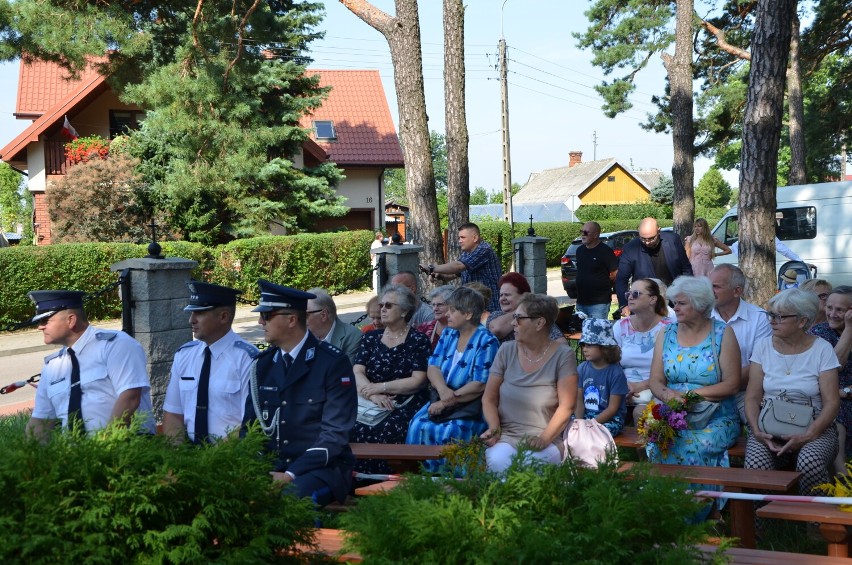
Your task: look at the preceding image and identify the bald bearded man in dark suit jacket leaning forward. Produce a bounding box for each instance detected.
[615,218,692,315]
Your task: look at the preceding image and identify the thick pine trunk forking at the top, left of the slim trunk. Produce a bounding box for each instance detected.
[340,0,443,263]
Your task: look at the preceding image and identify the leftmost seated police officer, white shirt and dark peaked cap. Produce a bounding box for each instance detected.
[27,290,154,438]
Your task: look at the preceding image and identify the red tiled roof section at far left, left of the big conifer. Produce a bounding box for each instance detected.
[15,60,100,119]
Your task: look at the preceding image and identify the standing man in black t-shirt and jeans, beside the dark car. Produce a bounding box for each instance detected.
[574,222,618,319]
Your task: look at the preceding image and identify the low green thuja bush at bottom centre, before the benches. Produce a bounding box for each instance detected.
[341,454,721,565]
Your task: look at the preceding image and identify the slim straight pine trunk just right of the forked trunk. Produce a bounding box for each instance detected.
[444,0,470,258]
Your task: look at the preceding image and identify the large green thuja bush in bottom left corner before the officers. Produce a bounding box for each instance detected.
[0,417,324,564]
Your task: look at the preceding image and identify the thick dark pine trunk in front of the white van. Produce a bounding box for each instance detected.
[739,0,796,307]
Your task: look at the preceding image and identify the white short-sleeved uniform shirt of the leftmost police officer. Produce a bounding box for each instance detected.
[33,326,155,433]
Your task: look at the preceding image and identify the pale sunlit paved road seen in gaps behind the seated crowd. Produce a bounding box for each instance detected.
[0,269,573,415]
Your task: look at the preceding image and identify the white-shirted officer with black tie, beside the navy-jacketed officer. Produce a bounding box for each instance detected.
[163,281,259,443]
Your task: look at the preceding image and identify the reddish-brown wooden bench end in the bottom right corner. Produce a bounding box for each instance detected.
[757,501,852,557]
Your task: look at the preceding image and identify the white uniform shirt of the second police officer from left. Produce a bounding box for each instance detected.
[163,330,258,439]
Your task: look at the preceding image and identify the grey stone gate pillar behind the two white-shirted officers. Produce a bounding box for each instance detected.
[110,257,198,414]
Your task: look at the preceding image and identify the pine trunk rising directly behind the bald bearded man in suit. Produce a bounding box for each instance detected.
[662,0,695,239]
